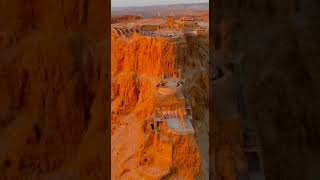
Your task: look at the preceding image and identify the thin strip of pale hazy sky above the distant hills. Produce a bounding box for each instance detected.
[111,0,209,7]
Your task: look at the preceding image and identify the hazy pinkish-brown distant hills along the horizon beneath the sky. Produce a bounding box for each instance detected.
[111,3,209,18]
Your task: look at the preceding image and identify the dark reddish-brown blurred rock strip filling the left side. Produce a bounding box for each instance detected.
[0,0,109,179]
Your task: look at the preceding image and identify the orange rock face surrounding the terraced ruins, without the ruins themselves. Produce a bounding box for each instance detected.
[112,27,208,179]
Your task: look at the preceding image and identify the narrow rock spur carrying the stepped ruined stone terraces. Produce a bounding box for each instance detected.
[141,76,199,178]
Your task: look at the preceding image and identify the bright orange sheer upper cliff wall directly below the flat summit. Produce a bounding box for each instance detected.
[111,34,179,77]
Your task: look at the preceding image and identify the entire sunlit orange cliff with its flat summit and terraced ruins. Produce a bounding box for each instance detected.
[111,13,208,179]
